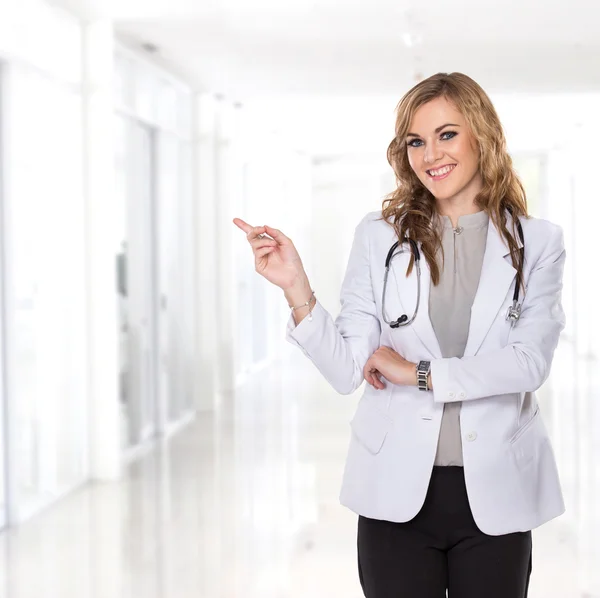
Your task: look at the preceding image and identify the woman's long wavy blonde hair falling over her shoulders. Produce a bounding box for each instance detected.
[382,73,529,285]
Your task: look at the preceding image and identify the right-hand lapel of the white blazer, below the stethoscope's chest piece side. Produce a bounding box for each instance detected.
[464,216,522,357]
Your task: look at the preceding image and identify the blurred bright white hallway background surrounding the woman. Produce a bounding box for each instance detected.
[0,0,600,598]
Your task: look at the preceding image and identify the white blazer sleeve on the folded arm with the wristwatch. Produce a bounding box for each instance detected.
[431,226,565,403]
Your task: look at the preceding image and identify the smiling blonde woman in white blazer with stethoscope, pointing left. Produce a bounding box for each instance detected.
[235,73,565,598]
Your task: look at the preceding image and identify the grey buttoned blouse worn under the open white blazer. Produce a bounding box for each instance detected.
[429,211,489,466]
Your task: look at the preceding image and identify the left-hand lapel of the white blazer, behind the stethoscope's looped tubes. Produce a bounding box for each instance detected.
[386,244,442,359]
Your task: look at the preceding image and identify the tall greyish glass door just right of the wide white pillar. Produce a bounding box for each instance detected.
[116,116,158,448]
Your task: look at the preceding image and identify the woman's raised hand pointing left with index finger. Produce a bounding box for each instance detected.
[233,218,308,291]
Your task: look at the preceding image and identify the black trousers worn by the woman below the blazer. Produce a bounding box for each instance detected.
[358,467,531,598]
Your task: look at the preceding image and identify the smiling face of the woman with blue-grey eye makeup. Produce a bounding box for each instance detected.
[406,97,482,207]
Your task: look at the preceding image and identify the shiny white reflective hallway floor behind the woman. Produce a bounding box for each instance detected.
[0,346,582,598]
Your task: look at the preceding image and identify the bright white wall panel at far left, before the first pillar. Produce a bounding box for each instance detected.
[0,1,89,523]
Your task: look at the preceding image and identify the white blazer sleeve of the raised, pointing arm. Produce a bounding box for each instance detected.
[286,215,381,394]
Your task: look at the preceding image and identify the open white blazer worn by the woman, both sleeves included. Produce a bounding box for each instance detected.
[287,212,565,535]
